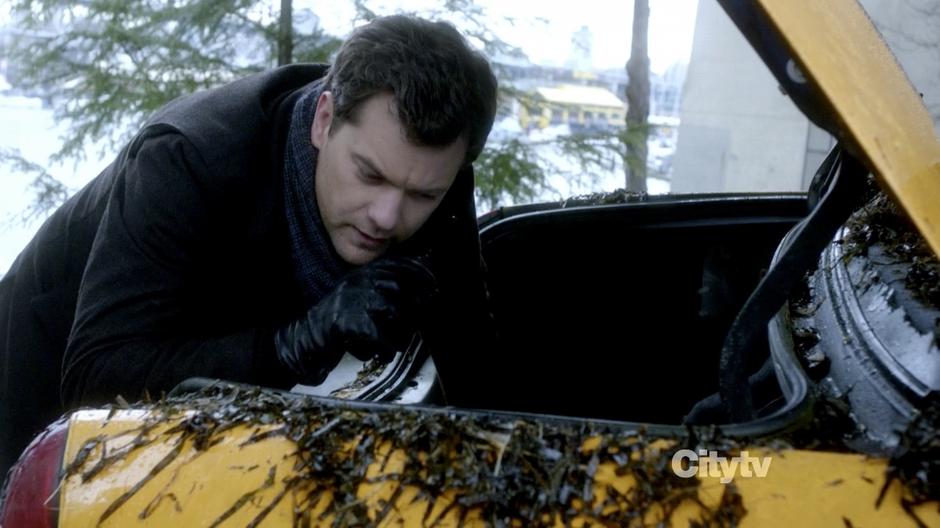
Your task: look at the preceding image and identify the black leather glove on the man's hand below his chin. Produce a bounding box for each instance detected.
[274,257,437,385]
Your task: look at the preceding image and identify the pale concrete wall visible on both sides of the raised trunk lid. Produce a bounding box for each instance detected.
[672,0,940,192]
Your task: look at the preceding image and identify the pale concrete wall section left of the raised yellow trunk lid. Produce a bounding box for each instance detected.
[672,0,808,192]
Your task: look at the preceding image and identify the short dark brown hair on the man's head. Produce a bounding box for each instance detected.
[326,15,496,164]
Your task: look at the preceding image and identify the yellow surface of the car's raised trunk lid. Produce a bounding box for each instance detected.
[758,0,940,255]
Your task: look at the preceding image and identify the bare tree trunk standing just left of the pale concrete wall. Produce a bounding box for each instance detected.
[624,0,650,192]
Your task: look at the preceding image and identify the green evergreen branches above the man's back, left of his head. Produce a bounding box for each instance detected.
[6,0,339,161]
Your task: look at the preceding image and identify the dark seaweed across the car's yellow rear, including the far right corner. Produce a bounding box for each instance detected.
[58,374,940,527]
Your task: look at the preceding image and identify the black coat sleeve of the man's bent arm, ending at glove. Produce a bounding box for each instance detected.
[62,125,287,407]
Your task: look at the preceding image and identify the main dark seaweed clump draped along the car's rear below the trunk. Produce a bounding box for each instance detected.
[68,385,746,526]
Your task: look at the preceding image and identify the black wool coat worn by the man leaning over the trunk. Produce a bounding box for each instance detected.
[0,64,489,476]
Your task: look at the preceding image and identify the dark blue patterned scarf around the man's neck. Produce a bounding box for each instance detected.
[284,81,349,306]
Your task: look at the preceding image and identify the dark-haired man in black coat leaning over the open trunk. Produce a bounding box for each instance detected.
[0,17,496,475]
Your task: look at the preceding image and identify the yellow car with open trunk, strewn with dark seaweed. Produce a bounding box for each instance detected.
[0,0,940,528]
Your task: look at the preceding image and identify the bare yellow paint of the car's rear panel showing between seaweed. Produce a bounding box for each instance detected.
[59,411,940,527]
